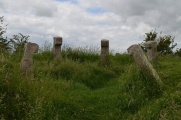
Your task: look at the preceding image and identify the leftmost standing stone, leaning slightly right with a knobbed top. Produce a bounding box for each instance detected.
[20,42,39,74]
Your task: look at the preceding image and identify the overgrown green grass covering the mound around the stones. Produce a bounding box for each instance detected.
[0,48,181,120]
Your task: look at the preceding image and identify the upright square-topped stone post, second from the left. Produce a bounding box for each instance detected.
[53,37,62,60]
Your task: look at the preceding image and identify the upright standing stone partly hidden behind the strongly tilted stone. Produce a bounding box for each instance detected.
[145,41,158,63]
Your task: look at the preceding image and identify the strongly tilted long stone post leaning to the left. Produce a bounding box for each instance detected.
[127,44,163,86]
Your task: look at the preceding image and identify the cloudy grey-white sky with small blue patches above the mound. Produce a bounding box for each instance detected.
[0,0,181,52]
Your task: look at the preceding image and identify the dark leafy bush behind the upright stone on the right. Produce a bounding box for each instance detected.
[144,31,177,55]
